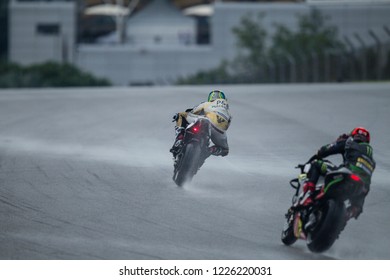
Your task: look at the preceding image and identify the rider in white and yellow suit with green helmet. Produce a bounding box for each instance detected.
[170,90,232,157]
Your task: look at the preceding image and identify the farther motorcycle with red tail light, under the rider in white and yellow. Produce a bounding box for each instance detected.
[172,117,211,186]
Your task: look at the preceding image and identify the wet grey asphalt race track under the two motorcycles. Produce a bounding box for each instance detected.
[0,83,390,260]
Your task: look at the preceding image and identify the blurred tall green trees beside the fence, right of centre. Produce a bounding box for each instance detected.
[180,9,344,84]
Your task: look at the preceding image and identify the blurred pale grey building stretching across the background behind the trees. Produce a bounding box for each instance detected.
[6,0,390,85]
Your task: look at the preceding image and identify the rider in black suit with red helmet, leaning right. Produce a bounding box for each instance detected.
[300,127,376,219]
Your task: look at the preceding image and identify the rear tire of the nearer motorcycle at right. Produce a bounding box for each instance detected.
[306,199,345,253]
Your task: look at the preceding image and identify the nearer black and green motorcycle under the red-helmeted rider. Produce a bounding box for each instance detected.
[281,160,367,253]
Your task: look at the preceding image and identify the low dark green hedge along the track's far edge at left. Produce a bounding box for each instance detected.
[0,62,111,88]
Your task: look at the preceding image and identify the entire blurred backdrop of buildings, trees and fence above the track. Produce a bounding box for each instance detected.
[0,0,390,88]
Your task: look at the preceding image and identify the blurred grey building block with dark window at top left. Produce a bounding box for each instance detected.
[9,0,77,65]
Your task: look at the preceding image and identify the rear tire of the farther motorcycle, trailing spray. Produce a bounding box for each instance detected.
[173,143,200,187]
